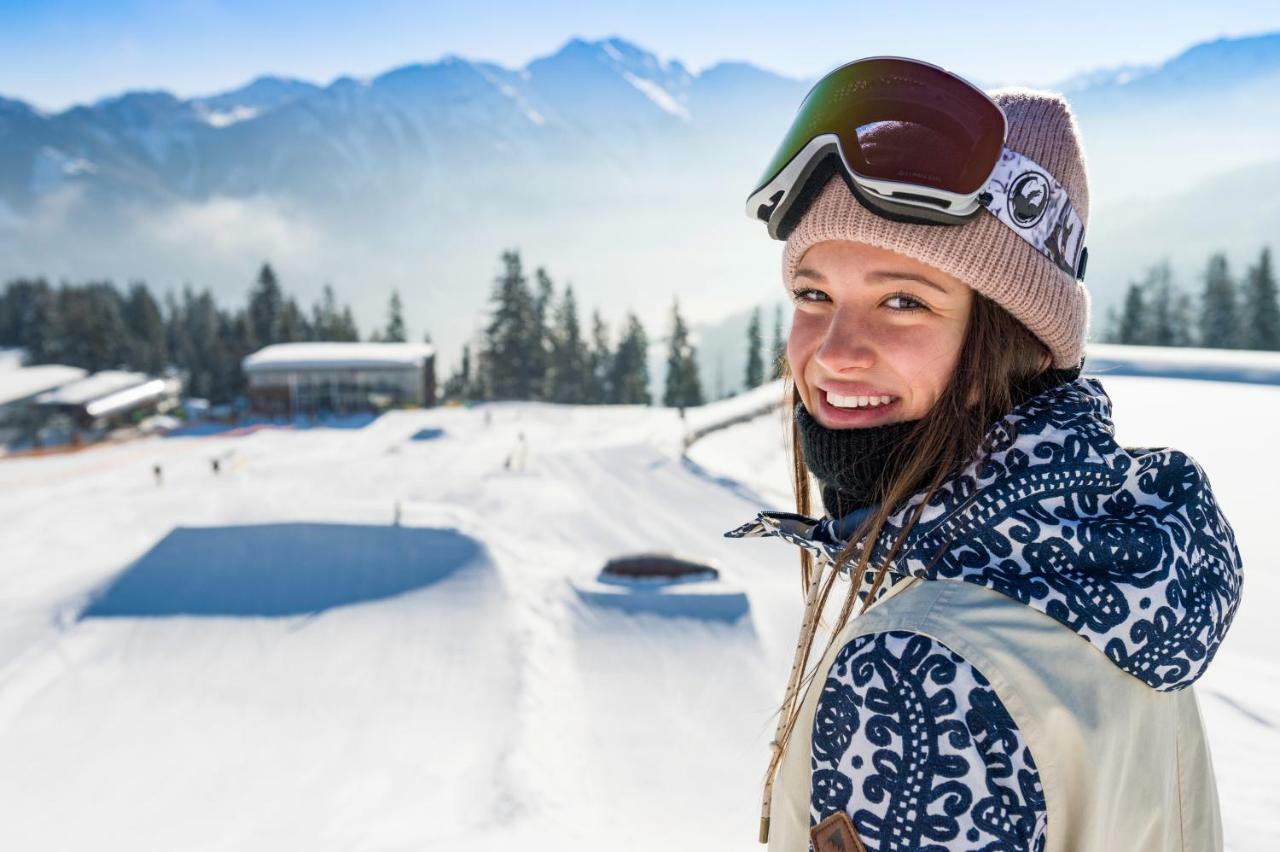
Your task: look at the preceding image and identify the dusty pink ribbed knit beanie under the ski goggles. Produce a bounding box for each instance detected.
[782,87,1089,367]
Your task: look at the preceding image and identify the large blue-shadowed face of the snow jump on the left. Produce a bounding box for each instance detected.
[81,523,486,618]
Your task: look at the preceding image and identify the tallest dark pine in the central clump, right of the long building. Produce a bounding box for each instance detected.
[483,249,543,399]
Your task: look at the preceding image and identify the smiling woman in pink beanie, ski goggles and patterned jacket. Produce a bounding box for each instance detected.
[726,58,1242,852]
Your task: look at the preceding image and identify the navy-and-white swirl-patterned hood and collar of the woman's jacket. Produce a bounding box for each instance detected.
[724,377,1243,691]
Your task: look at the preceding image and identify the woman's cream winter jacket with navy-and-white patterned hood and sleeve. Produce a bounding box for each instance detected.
[724,379,1242,852]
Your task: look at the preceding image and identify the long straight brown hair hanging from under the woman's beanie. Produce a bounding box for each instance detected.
[768,286,1052,779]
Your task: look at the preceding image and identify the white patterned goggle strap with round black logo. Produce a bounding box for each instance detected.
[979,147,1088,280]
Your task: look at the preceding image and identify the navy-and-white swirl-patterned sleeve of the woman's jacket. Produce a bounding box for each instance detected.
[809,631,1048,852]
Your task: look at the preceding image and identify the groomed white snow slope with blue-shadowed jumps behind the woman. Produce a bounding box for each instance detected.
[0,377,1280,852]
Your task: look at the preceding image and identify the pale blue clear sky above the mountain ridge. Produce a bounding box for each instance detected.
[0,0,1280,111]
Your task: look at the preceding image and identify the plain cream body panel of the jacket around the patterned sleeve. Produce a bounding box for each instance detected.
[768,578,1222,852]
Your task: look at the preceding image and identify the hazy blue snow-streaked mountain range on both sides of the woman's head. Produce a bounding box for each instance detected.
[0,33,1280,371]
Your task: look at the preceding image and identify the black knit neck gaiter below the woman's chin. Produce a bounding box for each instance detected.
[795,367,1080,518]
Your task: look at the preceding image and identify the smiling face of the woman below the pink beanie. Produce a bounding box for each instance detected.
[787,239,973,429]
